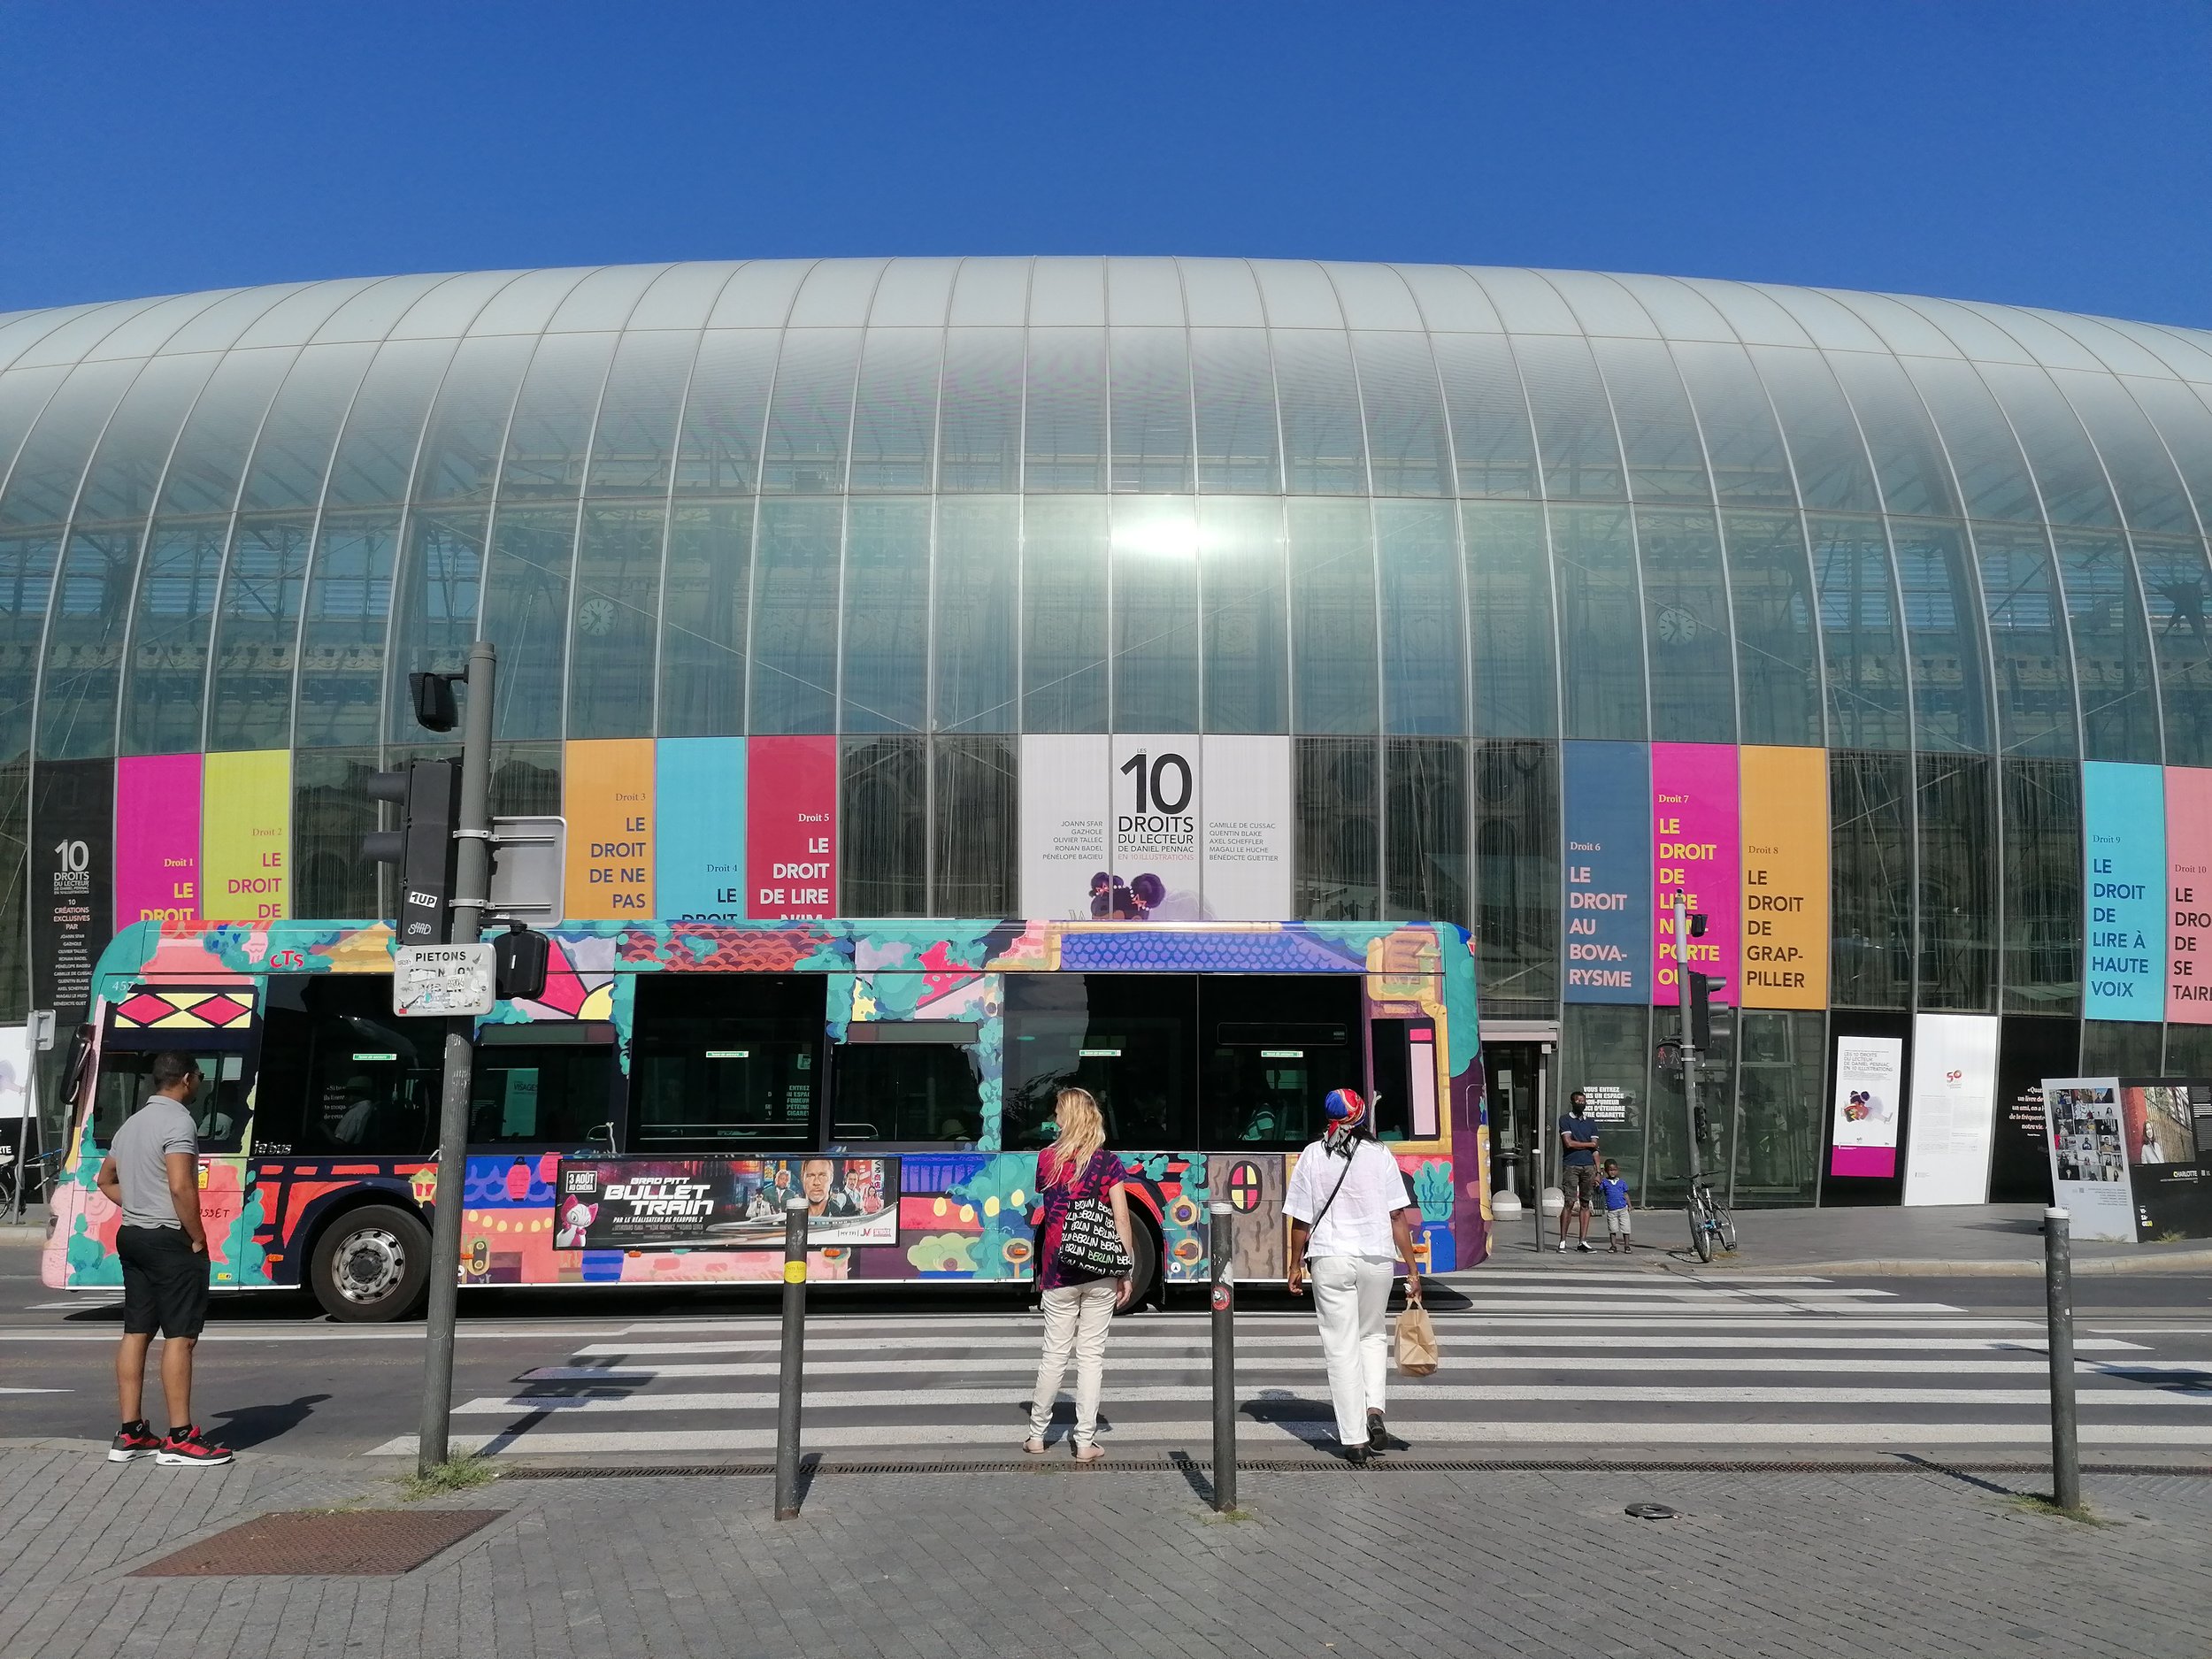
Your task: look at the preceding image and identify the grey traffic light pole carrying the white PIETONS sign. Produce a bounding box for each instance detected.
[416,640,498,1473]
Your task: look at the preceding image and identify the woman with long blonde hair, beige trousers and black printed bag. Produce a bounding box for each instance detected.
[1022,1088,1137,1463]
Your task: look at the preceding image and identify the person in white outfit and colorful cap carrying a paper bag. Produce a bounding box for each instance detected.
[1283,1088,1420,1463]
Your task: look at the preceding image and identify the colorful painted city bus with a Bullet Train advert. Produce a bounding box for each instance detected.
[44,920,1489,1321]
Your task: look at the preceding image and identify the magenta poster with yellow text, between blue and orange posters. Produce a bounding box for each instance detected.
[1653,743,1743,1007]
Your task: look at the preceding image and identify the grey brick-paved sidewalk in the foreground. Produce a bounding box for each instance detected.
[0,1447,2212,1659]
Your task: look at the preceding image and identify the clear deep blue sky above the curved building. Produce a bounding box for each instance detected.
[0,0,2212,326]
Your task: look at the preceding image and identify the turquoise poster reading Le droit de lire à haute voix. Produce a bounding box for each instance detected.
[2082,761,2166,1020]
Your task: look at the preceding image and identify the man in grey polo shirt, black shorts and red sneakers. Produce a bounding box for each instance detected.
[100,1053,230,1467]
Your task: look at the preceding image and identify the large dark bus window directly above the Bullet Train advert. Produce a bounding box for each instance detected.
[628,973,827,1155]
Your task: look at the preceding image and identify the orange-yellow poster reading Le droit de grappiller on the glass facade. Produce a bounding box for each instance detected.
[1741,748,1827,1009]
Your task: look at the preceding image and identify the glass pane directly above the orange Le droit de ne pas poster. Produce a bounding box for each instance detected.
[569,500,675,737]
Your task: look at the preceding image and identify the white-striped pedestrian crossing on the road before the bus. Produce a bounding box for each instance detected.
[374,1263,2212,1458]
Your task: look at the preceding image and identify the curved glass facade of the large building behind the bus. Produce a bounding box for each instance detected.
[0,259,2212,1199]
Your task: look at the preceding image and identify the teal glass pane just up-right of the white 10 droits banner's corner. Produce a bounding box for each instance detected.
[1290,500,1379,733]
